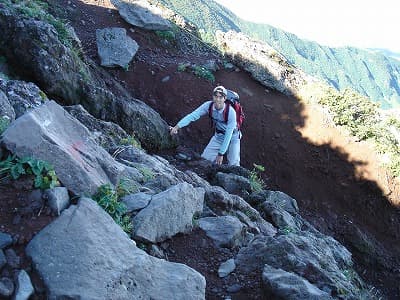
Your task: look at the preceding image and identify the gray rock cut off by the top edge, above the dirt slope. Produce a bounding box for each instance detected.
[111,0,171,30]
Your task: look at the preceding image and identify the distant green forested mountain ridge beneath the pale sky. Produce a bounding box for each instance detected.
[158,0,400,109]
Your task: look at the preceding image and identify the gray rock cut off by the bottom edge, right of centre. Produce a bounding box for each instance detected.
[262,265,333,300]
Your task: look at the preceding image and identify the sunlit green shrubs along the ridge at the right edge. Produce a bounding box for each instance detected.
[299,83,400,177]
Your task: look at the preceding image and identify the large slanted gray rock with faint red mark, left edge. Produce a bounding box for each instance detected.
[3,101,124,195]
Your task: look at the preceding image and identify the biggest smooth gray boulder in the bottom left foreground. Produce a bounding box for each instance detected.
[26,198,205,300]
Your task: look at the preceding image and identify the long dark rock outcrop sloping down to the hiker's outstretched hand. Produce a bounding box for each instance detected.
[0,4,175,150]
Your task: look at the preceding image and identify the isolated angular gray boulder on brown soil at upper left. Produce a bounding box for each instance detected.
[96,28,139,69]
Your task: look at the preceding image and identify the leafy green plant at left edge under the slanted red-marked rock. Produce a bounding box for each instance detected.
[0,155,60,190]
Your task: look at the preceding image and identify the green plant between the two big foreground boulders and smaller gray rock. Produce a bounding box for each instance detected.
[92,184,133,234]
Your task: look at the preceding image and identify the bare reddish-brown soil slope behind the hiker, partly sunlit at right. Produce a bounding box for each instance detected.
[0,0,400,299]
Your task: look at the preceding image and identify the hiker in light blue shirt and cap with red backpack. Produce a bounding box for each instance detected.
[169,86,241,166]
